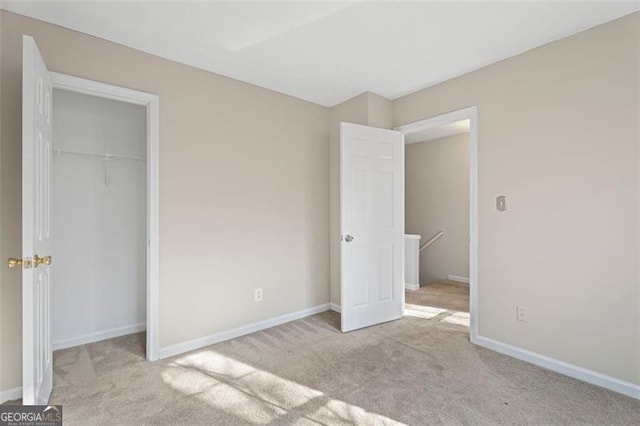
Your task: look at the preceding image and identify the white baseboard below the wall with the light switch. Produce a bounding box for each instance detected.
[474,336,640,399]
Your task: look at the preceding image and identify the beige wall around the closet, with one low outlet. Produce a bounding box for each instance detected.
[0,11,329,396]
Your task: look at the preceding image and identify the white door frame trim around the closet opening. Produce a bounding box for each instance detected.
[51,72,160,361]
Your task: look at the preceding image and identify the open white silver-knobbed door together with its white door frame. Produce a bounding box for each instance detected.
[339,107,478,336]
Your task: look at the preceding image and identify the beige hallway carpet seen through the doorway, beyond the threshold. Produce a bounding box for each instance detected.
[405,280,469,312]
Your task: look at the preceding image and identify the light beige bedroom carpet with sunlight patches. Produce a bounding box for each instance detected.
[45,312,640,425]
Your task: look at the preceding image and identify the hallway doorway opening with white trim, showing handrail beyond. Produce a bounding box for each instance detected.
[396,107,478,342]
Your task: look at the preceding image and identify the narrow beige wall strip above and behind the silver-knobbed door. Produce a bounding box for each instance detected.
[329,92,393,305]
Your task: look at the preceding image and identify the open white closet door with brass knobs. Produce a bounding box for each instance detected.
[22,36,53,405]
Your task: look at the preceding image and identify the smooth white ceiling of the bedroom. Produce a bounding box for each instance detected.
[1,0,640,106]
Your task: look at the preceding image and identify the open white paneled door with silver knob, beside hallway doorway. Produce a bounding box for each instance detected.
[340,123,404,332]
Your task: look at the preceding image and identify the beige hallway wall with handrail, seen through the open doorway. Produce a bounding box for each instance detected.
[404,133,469,285]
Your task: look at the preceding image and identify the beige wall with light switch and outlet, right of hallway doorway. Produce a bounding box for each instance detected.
[394,13,640,384]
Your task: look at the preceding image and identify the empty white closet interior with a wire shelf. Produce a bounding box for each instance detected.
[51,89,147,350]
